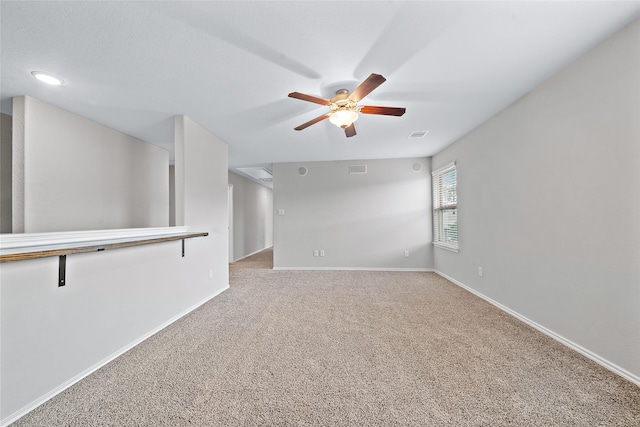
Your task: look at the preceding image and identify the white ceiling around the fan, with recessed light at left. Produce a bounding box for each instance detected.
[0,0,640,186]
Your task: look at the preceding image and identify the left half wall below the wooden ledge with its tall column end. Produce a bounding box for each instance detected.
[0,113,229,424]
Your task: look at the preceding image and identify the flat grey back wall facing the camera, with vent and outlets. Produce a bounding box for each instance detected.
[273,158,433,270]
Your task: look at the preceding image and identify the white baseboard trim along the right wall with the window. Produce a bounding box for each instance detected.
[434,270,640,386]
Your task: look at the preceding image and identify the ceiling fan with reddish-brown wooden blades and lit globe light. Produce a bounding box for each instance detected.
[289,74,406,138]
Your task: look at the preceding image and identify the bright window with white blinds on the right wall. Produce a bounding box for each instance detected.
[431,162,458,252]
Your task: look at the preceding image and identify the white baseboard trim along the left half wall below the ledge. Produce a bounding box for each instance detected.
[0,284,229,427]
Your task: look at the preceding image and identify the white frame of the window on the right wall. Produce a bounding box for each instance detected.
[431,162,460,252]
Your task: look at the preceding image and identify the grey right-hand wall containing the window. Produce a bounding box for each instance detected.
[433,22,640,381]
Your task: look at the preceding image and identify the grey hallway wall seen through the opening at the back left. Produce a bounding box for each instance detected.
[229,172,273,260]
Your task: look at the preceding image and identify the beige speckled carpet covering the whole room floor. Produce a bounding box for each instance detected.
[15,250,640,426]
